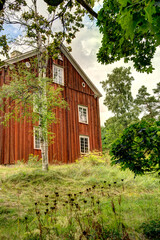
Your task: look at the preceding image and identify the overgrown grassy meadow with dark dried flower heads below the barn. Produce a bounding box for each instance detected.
[0,154,160,240]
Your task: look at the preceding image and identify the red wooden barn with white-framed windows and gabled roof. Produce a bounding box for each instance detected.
[0,47,101,164]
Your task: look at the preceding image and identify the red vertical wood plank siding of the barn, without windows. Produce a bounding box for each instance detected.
[0,55,102,164]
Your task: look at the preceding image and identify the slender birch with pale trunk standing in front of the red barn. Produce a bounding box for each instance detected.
[1,0,92,170]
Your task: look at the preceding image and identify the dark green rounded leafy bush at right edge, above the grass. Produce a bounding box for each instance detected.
[110,120,160,174]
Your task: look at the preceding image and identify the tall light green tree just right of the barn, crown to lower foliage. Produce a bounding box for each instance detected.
[102,67,139,150]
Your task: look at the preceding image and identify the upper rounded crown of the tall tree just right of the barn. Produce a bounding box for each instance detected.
[101,67,134,117]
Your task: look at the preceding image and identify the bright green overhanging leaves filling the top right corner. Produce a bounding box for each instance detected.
[97,0,160,73]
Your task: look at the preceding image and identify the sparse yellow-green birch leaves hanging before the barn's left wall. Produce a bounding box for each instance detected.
[0,61,67,127]
